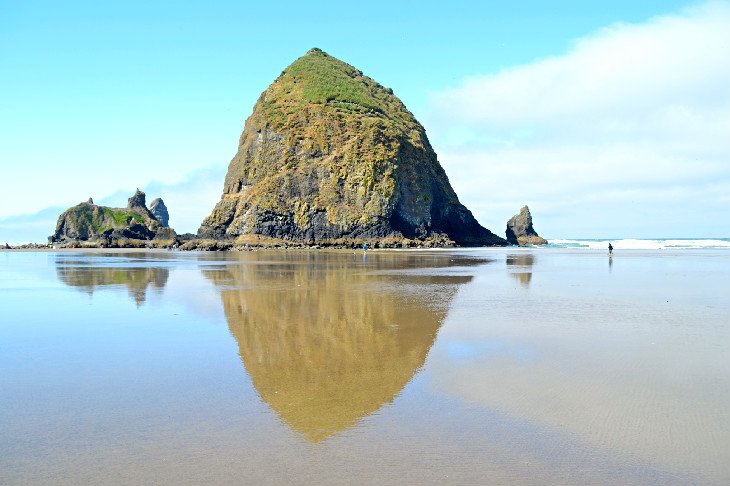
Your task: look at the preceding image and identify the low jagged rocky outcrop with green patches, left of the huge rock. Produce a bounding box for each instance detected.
[48,189,175,243]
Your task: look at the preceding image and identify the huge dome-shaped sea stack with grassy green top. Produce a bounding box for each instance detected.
[198,49,506,245]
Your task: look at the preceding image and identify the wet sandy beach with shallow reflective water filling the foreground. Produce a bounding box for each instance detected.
[0,249,730,485]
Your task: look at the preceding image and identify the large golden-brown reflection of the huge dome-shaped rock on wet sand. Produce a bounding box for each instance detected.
[206,254,478,442]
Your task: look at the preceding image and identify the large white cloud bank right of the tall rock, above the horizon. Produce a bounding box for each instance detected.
[426,2,730,237]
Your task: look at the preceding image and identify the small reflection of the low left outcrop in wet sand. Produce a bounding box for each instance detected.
[56,260,169,305]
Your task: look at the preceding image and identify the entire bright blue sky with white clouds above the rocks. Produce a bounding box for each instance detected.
[0,0,730,242]
